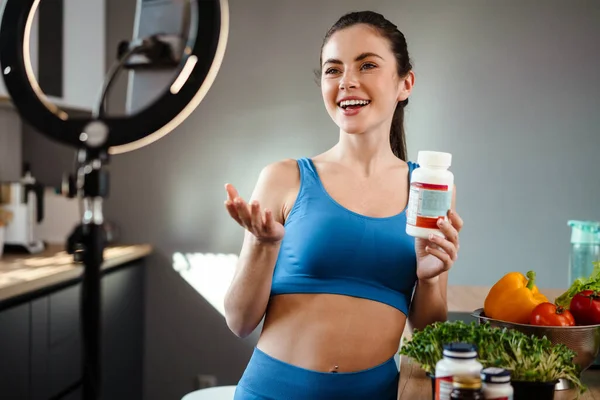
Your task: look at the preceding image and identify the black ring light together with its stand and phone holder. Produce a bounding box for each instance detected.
[0,0,229,400]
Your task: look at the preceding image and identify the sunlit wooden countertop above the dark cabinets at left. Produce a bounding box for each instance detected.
[0,245,152,302]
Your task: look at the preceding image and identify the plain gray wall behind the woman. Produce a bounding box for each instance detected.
[19,0,600,400]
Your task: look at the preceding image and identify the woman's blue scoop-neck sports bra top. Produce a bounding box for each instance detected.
[271,158,418,315]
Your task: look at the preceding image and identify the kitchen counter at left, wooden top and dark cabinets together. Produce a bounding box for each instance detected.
[0,245,151,399]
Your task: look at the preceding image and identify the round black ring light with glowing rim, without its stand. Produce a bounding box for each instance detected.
[0,0,229,154]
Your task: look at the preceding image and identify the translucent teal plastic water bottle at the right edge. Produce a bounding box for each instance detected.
[568,221,600,285]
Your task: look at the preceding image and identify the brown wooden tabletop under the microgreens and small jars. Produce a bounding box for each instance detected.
[398,356,600,400]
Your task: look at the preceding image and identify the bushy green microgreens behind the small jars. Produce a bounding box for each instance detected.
[399,321,587,392]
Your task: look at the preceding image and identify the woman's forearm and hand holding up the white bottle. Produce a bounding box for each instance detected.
[408,186,463,329]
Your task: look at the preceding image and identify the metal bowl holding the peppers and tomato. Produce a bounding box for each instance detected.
[471,308,600,372]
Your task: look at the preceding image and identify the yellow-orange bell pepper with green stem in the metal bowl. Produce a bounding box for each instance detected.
[483,271,548,324]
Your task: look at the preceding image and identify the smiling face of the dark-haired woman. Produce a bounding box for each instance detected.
[321,24,412,134]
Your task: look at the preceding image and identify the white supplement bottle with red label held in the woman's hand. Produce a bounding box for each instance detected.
[406,151,454,239]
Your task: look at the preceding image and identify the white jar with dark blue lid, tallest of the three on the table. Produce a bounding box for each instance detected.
[435,343,483,400]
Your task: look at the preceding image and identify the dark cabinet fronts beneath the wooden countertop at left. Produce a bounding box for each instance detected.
[0,261,144,400]
